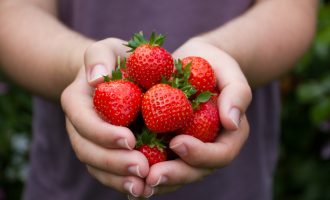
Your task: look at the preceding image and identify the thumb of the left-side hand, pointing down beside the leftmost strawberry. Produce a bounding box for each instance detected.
[84,38,128,86]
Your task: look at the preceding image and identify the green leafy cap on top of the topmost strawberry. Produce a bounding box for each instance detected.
[125,31,165,52]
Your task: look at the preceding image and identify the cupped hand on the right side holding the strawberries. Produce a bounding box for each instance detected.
[144,38,252,198]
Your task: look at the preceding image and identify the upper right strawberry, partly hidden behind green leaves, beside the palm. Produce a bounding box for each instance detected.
[182,56,216,93]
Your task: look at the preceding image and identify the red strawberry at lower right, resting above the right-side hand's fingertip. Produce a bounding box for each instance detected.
[178,101,220,142]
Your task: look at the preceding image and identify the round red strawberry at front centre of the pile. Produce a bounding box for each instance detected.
[142,84,193,133]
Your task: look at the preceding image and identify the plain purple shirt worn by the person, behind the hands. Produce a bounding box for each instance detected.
[24,0,279,200]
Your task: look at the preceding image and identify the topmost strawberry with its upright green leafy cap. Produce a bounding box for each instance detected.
[126,32,174,89]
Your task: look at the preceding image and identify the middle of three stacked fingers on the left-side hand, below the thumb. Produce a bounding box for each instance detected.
[67,118,149,178]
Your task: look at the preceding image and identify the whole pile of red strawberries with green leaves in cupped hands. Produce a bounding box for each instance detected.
[93,32,220,165]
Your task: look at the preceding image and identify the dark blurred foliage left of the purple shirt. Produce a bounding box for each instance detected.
[0,74,31,200]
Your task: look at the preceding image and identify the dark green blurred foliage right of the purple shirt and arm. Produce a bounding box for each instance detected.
[274,1,330,200]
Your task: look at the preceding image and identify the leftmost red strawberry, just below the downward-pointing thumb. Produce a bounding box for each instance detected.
[93,80,143,126]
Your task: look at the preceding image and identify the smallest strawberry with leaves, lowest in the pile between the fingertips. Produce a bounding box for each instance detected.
[136,128,167,166]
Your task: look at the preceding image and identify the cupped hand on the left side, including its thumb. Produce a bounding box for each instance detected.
[61,38,149,196]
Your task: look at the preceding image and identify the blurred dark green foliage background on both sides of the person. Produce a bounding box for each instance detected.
[0,0,330,200]
